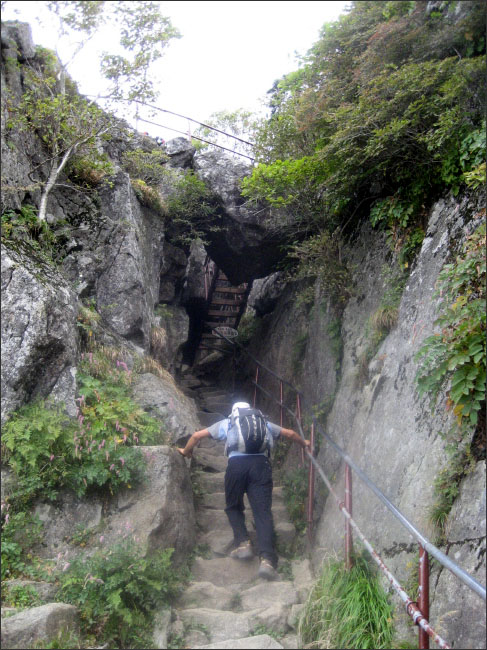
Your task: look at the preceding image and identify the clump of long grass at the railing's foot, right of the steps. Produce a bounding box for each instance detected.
[299,557,394,648]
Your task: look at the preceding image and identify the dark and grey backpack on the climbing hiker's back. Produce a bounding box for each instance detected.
[225,408,270,456]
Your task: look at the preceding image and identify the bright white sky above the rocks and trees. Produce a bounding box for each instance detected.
[2,0,349,140]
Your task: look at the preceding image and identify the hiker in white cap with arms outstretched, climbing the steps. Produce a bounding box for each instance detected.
[178,402,310,580]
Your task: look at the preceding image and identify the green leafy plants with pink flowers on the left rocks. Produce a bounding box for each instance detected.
[2,344,165,508]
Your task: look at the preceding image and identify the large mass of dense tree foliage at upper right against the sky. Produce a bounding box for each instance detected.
[243,1,486,280]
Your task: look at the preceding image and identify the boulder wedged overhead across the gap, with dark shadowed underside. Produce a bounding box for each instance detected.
[193,150,282,285]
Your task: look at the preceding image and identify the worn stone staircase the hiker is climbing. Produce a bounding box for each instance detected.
[170,378,312,648]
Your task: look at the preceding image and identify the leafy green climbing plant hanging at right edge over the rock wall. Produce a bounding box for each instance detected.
[415,224,486,429]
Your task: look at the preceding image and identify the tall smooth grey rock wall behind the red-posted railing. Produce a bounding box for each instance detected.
[242,190,485,648]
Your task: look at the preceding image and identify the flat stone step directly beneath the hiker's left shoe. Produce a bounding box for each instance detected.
[192,557,260,588]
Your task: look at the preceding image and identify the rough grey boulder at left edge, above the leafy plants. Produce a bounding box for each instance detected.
[1,240,78,423]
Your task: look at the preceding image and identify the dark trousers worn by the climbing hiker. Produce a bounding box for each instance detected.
[225,456,277,567]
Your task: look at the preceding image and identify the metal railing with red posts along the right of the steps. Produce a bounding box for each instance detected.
[217,333,486,648]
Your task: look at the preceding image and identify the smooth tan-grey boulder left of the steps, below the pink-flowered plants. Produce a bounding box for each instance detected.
[32,446,195,562]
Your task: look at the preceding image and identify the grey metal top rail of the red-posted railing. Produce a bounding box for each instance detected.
[219,334,486,600]
